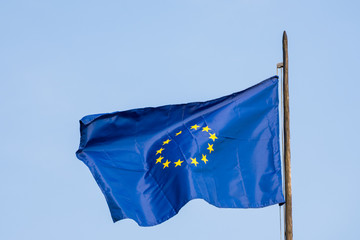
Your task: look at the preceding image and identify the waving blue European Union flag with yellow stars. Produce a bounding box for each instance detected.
[76,76,284,226]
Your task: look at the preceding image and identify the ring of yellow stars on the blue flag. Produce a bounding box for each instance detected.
[155,124,218,169]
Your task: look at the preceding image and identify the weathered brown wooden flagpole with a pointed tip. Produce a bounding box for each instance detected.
[282,31,293,240]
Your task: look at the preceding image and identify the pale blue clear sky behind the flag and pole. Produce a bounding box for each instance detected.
[0,0,360,240]
